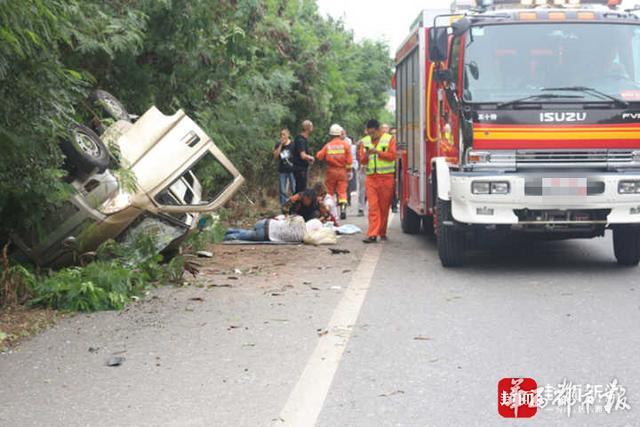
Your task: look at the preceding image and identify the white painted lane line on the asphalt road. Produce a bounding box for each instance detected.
[279,214,393,427]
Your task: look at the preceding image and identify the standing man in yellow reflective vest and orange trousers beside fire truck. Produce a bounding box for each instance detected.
[359,120,396,243]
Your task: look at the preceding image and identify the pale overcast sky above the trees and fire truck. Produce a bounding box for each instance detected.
[318,0,640,56]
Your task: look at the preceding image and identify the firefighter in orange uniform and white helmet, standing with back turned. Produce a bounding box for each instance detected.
[316,124,353,219]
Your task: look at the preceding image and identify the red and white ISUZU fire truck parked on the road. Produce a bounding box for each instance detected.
[395,0,640,267]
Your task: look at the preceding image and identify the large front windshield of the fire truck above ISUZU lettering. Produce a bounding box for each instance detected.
[462,22,640,103]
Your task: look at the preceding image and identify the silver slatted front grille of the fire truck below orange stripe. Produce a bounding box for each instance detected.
[515,150,634,168]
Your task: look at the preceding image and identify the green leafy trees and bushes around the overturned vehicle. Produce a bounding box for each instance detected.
[0,0,391,310]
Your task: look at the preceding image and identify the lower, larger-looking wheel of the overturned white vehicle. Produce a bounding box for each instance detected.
[60,124,109,173]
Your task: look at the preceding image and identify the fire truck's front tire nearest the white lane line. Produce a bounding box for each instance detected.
[436,199,466,267]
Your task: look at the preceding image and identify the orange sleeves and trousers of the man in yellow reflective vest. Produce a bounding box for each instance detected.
[358,137,396,237]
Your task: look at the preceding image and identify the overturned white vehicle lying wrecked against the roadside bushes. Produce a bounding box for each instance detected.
[12,94,244,267]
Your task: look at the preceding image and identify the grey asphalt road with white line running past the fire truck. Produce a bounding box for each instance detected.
[0,212,640,426]
